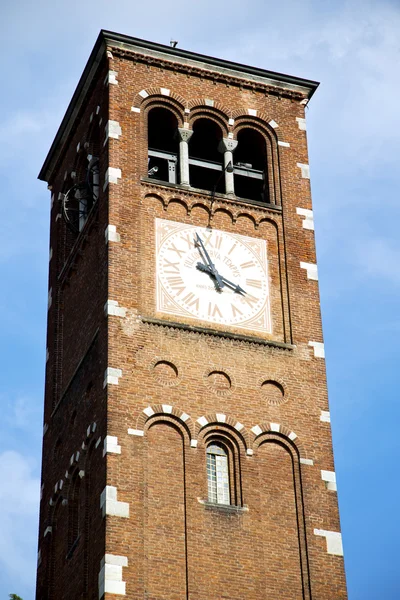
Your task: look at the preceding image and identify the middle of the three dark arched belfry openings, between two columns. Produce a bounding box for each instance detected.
[189,118,225,193]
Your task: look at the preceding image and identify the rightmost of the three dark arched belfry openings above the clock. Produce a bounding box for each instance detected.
[233,128,270,203]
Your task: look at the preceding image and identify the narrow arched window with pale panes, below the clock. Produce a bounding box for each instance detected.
[207,444,230,504]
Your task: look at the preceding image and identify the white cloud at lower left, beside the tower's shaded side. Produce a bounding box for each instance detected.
[0,450,40,586]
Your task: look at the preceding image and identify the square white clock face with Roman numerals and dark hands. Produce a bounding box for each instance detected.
[156,219,271,333]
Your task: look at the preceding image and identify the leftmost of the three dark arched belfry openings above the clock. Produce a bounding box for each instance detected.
[148,106,179,183]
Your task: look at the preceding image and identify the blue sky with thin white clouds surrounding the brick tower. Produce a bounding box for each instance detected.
[0,0,400,600]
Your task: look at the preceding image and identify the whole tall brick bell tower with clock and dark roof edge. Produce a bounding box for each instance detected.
[36,31,347,600]
